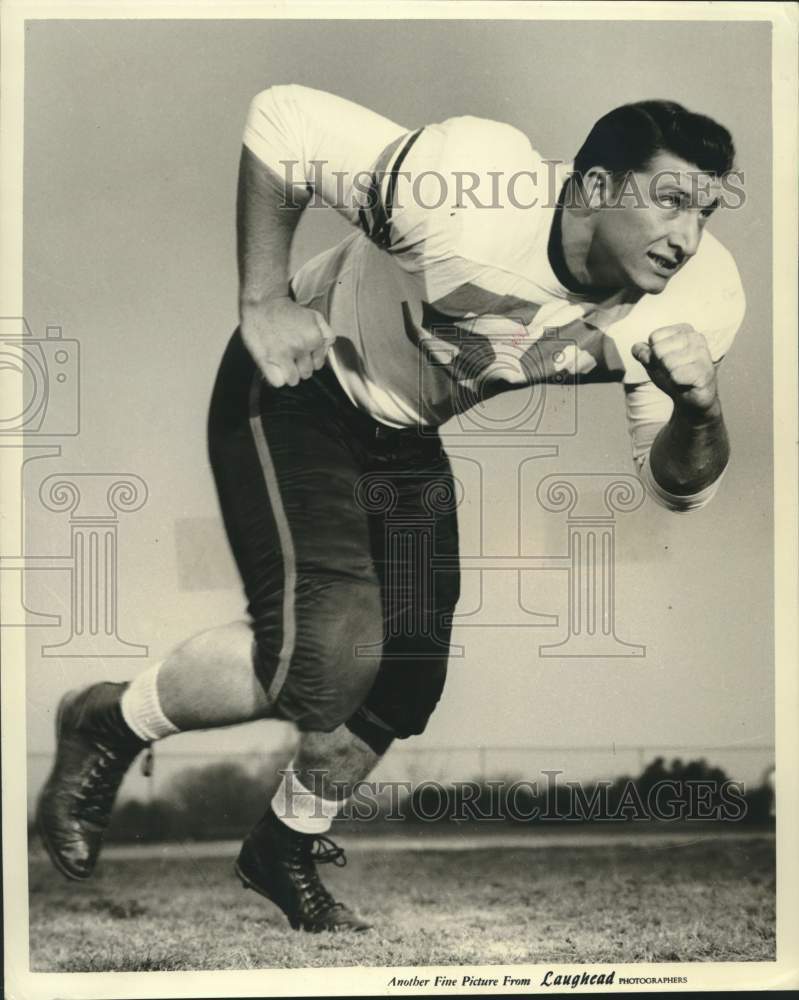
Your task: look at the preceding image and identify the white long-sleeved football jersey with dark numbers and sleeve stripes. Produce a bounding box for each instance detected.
[244,86,745,504]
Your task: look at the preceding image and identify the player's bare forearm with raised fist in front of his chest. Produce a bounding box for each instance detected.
[632,324,730,496]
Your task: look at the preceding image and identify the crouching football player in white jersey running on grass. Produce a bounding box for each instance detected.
[38,86,744,931]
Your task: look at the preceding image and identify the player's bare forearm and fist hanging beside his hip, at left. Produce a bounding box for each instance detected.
[236,146,334,388]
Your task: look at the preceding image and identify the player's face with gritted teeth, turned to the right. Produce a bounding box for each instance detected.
[588,152,721,295]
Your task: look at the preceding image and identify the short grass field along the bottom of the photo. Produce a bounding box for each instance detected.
[30,838,775,972]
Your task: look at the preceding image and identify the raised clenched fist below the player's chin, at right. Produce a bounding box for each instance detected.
[632,323,718,414]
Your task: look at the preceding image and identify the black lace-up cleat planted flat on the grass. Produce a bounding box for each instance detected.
[235,809,372,933]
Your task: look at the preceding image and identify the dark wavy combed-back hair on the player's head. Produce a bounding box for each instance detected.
[574,101,735,177]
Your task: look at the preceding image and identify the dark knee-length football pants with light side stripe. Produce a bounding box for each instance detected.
[209,331,459,752]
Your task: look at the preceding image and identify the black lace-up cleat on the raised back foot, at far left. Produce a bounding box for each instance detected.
[36,683,148,879]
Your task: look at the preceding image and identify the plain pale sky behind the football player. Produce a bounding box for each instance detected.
[18,21,774,804]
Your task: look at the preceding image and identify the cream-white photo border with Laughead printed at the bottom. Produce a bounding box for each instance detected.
[0,0,799,1000]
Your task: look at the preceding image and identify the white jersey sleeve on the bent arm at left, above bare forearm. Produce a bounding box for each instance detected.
[244,84,407,224]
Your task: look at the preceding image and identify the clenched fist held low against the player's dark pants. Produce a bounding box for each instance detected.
[241,297,336,389]
